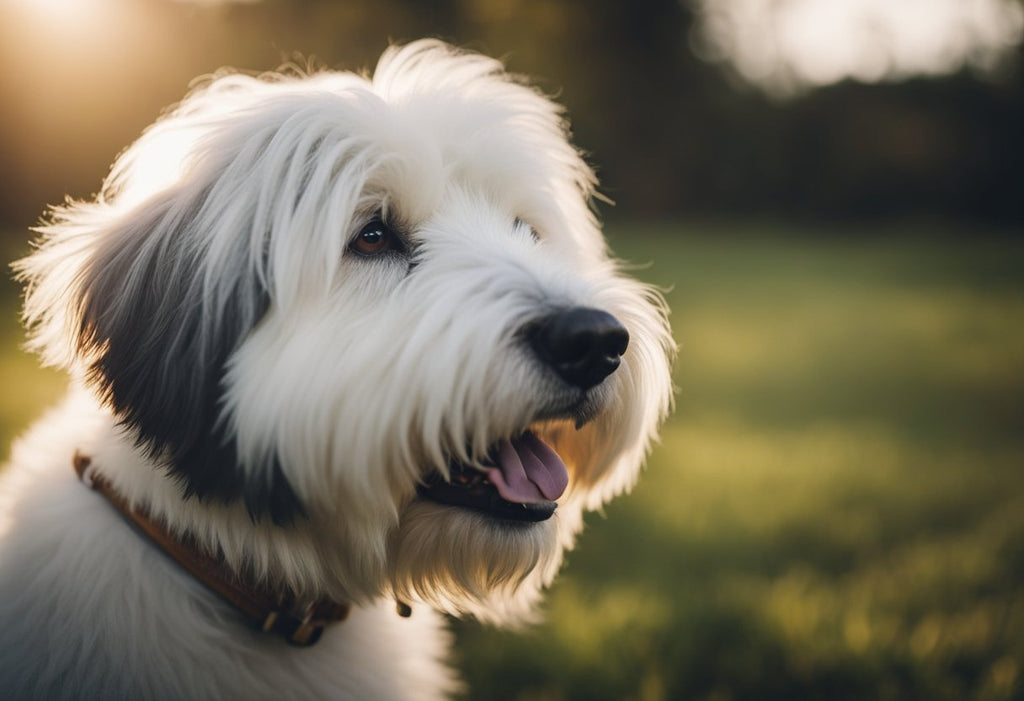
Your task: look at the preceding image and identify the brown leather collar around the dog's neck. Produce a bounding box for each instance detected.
[72,451,348,647]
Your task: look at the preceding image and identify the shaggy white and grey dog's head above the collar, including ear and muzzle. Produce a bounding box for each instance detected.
[22,42,673,619]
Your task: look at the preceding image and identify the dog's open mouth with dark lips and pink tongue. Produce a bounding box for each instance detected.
[419,431,569,522]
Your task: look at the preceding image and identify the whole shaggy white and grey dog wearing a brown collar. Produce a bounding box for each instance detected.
[0,40,675,699]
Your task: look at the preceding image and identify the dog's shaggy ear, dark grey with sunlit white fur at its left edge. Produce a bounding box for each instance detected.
[15,184,302,522]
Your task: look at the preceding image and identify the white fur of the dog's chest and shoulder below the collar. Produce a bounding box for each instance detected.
[0,390,454,699]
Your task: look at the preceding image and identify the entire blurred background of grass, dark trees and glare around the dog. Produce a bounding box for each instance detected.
[0,0,1024,701]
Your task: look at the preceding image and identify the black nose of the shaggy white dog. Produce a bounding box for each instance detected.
[527,307,630,390]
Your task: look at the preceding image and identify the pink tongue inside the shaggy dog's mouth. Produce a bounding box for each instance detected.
[486,431,569,503]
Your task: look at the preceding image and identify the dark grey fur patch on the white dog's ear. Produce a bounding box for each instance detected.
[79,190,303,523]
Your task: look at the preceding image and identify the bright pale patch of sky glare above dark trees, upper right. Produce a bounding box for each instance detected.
[692,0,1024,94]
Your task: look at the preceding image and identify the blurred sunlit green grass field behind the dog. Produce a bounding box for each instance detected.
[0,226,1024,701]
